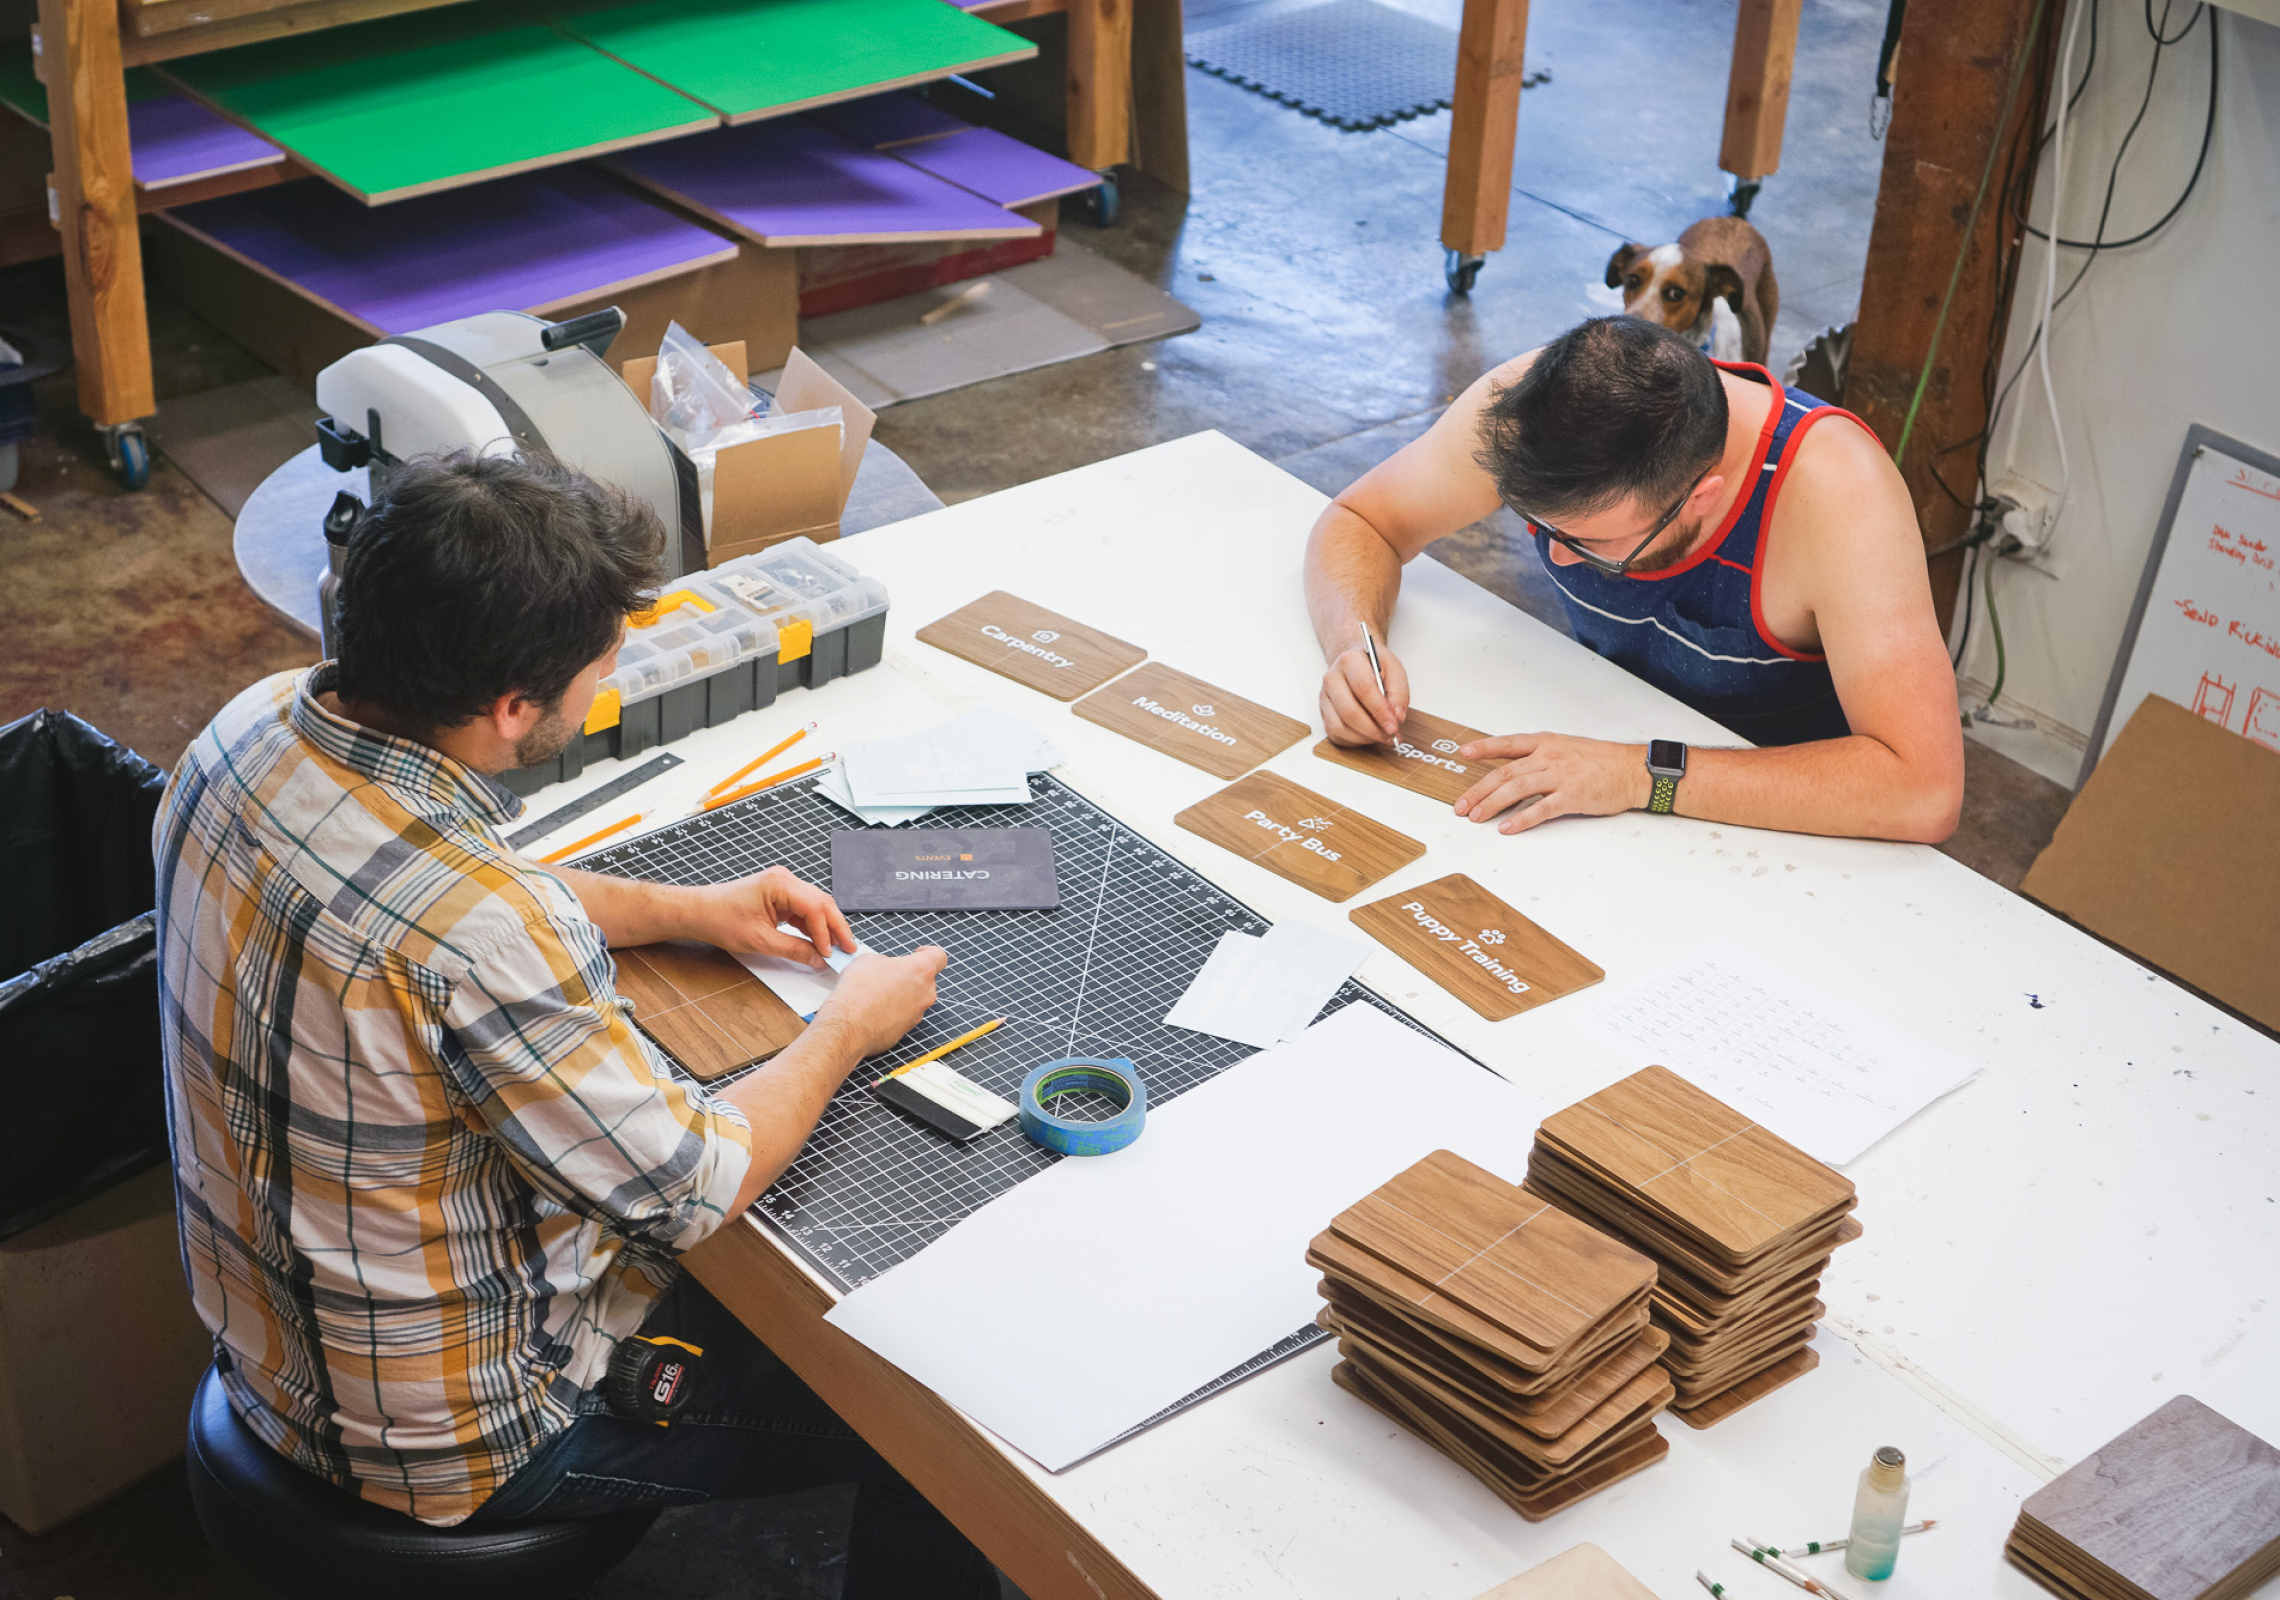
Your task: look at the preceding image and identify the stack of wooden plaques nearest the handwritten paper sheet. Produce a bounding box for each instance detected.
[1528,1067,1860,1427]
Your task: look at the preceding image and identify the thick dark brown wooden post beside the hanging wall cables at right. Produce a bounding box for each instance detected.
[1845,0,2061,627]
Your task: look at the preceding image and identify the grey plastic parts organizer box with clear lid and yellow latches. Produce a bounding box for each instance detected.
[499,538,887,795]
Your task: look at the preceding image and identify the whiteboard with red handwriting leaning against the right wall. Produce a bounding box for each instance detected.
[2075,422,2280,789]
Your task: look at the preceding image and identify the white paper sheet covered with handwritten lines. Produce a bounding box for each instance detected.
[1569,939,1979,1167]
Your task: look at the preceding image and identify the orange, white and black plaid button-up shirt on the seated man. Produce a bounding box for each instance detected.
[153,666,750,1525]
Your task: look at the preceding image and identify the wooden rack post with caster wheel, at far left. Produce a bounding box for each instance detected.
[39,0,157,426]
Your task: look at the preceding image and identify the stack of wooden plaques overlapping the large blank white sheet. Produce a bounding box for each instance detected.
[1306,1151,1674,1523]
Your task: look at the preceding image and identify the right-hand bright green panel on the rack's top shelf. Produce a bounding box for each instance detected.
[552,0,1037,123]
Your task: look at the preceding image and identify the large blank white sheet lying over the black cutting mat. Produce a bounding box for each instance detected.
[828,1005,1544,1472]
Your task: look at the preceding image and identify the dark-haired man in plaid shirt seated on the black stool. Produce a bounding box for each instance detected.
[153,456,994,1600]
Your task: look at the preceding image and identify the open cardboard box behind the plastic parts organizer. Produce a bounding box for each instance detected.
[620,342,878,568]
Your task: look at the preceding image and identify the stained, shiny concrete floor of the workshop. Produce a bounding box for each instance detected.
[0,0,2066,1600]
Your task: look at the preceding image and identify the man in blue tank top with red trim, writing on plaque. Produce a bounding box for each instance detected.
[1306,317,1963,843]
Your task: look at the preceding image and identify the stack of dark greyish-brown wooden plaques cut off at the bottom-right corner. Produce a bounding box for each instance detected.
[2004,1395,2280,1600]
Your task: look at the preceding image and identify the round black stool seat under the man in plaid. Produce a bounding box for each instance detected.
[189,1368,657,1600]
